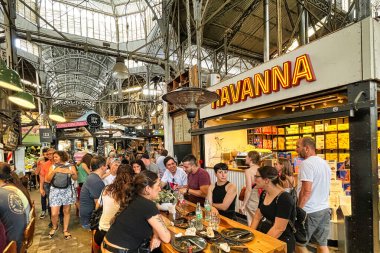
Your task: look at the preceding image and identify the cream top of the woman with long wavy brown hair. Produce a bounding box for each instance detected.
[98,192,120,231]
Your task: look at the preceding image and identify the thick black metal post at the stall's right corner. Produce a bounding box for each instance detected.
[346,81,380,253]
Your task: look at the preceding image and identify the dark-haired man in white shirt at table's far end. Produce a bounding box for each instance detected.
[161,156,187,190]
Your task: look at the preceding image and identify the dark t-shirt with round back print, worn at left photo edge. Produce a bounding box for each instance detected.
[0,188,26,251]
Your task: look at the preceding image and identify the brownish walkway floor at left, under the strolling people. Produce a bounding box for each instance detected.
[28,189,91,253]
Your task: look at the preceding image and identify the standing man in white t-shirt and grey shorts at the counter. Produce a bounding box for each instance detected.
[296,137,331,253]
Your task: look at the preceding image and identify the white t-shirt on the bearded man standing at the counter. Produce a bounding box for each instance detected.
[297,156,331,213]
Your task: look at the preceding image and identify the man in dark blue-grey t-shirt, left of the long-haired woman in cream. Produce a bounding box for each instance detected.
[79,156,107,230]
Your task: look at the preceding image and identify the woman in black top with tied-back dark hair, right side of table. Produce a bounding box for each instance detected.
[251,166,295,253]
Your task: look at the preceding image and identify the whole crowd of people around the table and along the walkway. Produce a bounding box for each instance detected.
[0,137,331,252]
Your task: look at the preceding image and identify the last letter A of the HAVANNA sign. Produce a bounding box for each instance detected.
[292,54,316,86]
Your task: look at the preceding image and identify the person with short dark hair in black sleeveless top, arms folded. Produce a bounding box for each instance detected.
[207,163,237,219]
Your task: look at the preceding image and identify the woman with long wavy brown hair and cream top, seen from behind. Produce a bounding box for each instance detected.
[94,164,132,246]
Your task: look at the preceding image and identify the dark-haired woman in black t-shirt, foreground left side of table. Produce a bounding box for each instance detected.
[102,170,170,253]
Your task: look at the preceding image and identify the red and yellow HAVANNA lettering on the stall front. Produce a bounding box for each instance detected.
[211,54,316,109]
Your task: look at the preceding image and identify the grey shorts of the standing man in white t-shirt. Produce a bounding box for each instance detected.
[297,208,331,246]
